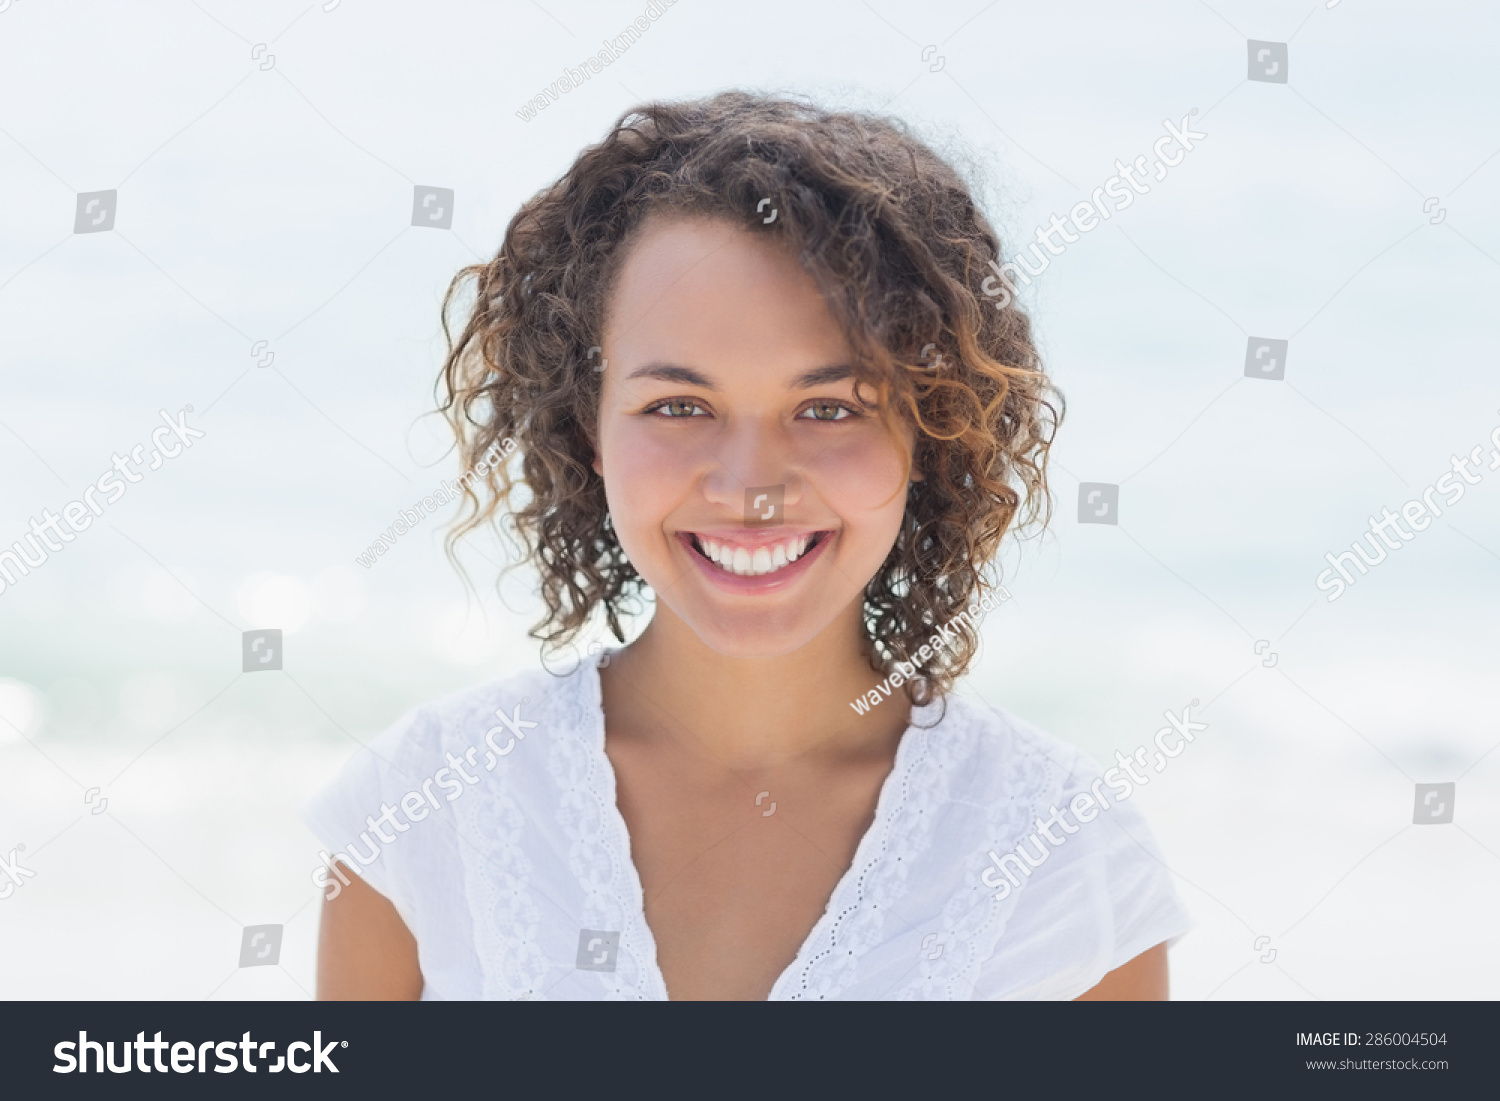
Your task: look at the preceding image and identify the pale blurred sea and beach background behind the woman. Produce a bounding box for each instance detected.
[0,0,1500,999]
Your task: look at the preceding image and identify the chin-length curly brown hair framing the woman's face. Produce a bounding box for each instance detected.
[438,92,1064,704]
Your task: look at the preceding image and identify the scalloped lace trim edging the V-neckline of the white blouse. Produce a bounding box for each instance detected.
[584,660,935,1002]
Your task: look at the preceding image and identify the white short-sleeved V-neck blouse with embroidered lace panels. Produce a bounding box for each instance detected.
[305,662,1190,1001]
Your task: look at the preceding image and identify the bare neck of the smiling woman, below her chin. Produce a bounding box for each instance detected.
[602,605,911,770]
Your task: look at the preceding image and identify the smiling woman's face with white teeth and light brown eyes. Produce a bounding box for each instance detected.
[594,218,912,657]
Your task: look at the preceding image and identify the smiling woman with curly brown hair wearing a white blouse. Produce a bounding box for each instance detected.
[309,93,1185,999]
